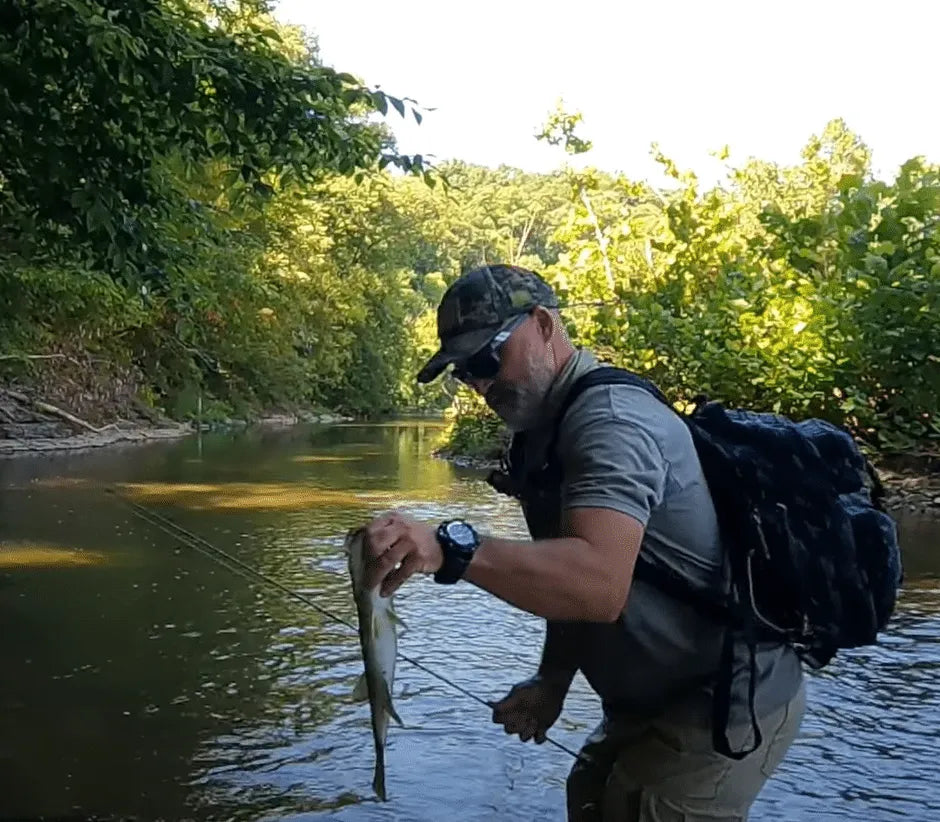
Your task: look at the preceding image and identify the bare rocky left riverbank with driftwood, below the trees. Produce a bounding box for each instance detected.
[0,388,350,456]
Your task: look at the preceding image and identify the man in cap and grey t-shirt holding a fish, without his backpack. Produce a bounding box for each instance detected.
[367,265,805,822]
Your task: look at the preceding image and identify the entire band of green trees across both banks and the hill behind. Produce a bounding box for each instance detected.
[0,12,940,466]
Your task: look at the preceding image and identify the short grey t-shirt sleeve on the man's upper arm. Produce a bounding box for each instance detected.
[558,394,668,526]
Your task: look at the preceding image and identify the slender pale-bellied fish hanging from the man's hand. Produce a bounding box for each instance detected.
[344,528,404,802]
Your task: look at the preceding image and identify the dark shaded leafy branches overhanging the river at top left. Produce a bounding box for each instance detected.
[0,0,424,283]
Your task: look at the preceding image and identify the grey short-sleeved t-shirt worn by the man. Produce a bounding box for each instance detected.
[525,350,802,725]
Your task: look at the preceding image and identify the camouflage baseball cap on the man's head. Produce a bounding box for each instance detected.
[418,265,558,382]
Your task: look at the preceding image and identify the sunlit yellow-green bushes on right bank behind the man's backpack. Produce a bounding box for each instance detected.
[546,121,940,448]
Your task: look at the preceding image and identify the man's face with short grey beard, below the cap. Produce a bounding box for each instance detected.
[464,311,555,431]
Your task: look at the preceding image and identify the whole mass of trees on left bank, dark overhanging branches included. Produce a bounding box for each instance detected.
[0,0,433,418]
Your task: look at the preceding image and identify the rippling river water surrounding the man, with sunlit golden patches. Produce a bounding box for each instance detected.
[0,421,940,822]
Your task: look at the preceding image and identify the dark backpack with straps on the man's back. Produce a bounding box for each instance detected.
[500,367,902,759]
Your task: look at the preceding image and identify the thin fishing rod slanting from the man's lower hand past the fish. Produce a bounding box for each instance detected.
[105,488,580,759]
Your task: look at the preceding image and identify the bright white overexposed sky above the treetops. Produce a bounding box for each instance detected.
[276,0,940,188]
